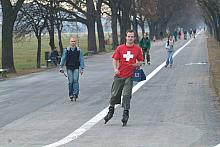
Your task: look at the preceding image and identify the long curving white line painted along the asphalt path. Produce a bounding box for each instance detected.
[43,33,199,147]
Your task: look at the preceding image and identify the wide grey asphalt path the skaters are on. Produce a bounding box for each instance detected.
[0,32,220,147]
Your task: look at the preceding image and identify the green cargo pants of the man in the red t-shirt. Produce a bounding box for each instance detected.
[109,77,133,110]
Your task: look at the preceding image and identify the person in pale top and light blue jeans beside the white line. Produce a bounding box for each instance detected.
[165,35,174,67]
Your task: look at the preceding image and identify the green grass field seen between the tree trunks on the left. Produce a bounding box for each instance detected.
[0,34,110,73]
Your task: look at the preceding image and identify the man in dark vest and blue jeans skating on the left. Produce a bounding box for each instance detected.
[60,37,84,101]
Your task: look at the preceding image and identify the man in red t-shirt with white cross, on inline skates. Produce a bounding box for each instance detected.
[104,30,143,126]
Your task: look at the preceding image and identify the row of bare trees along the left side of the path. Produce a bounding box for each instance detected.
[0,0,217,72]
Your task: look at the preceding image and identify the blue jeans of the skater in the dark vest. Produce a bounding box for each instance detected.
[67,69,79,96]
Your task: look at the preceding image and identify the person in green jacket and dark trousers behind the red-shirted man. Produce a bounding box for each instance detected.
[139,32,151,65]
